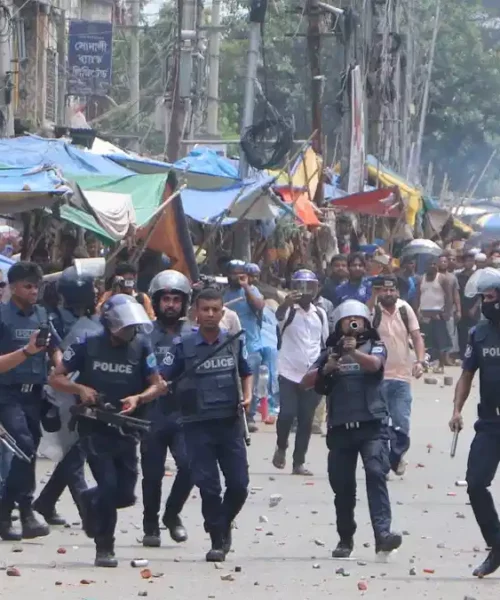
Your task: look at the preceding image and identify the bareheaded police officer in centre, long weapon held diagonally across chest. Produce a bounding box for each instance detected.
[123,288,252,562]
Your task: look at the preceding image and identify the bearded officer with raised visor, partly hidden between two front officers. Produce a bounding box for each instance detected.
[141,270,193,547]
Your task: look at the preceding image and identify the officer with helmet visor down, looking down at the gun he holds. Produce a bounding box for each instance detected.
[50,294,166,567]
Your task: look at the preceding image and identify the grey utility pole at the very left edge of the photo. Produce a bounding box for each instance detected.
[0,0,14,137]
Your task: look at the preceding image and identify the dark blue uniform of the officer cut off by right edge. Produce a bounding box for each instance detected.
[462,321,500,549]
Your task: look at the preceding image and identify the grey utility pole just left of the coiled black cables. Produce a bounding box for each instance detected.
[234,0,266,260]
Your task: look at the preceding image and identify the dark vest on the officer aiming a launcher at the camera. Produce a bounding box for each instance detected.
[327,340,387,427]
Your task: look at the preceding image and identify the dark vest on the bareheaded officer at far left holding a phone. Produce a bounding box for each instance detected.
[0,303,48,386]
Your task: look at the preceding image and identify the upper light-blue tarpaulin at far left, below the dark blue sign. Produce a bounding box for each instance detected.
[0,135,131,176]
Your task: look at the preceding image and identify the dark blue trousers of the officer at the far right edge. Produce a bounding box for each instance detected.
[466,419,500,548]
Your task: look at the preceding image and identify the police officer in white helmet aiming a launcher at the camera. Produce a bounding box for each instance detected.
[304,300,402,558]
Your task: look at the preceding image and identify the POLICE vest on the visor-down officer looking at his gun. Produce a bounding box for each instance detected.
[77,333,148,408]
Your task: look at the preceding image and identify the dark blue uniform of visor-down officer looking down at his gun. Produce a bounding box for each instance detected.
[63,330,158,551]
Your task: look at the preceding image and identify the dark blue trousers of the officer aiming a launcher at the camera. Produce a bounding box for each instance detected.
[326,421,391,539]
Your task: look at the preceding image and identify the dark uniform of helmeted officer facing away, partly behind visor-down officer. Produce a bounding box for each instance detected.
[33,308,103,525]
